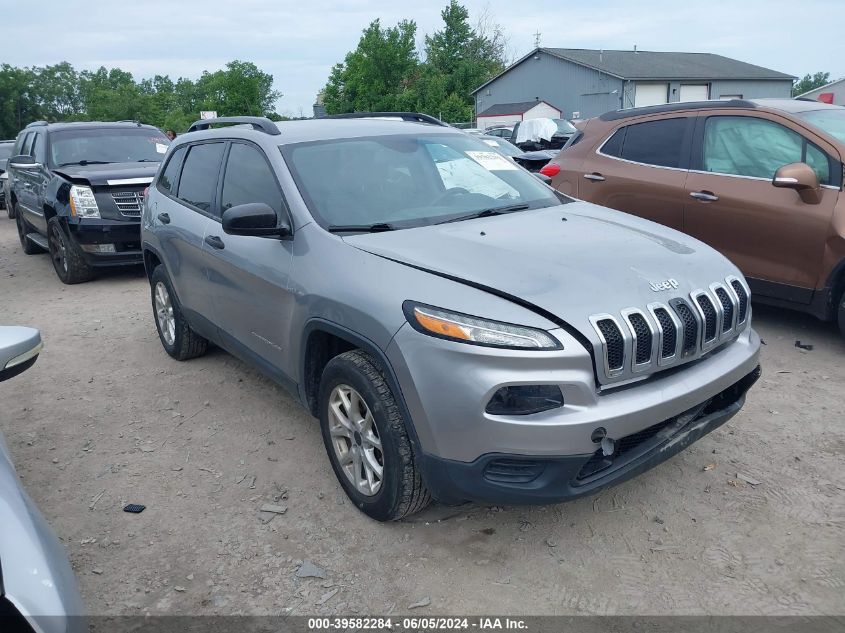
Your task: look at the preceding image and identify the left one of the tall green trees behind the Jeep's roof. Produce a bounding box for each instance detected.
[323,20,419,114]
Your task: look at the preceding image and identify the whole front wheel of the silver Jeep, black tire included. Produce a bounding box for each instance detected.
[319,350,431,521]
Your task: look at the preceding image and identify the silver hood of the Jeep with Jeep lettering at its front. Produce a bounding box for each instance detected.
[344,201,740,343]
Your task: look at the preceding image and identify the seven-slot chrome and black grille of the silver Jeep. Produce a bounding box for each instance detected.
[590,277,750,383]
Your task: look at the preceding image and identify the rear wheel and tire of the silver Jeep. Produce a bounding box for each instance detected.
[150,264,208,360]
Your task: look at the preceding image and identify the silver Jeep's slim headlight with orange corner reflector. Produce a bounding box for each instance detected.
[402,301,563,349]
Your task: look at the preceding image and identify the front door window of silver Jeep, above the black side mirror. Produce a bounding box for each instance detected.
[221,143,282,216]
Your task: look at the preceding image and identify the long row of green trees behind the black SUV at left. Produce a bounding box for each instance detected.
[0,60,281,139]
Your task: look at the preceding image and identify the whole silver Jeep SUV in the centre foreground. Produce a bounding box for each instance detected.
[142,113,760,520]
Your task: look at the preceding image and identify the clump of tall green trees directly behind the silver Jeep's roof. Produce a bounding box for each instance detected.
[323,0,506,122]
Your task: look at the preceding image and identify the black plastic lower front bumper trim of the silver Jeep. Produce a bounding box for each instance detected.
[420,366,760,505]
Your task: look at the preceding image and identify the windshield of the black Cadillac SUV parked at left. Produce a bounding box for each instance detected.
[50,128,170,167]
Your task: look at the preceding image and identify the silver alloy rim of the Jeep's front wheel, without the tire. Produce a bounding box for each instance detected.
[329,385,384,497]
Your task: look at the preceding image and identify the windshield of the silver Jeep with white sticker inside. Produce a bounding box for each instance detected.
[280,134,560,229]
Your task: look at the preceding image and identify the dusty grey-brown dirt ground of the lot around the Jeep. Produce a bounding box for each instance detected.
[0,213,845,615]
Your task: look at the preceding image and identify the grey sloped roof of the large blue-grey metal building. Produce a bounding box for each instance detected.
[472,48,797,94]
